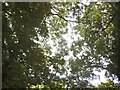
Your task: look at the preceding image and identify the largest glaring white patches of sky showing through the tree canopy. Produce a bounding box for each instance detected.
[34,0,117,86]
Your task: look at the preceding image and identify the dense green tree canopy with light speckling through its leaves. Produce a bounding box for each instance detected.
[2,2,120,89]
